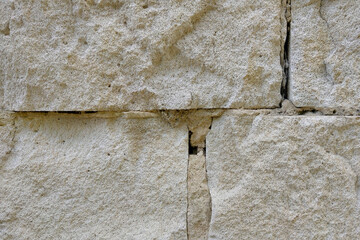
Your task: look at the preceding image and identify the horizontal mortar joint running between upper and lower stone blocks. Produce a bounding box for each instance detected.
[11,105,360,120]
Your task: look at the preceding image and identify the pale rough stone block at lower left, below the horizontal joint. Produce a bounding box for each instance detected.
[0,115,188,240]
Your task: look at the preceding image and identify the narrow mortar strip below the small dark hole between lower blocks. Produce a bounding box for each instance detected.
[187,150,211,240]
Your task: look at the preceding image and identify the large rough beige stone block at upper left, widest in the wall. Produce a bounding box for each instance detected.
[0,0,282,111]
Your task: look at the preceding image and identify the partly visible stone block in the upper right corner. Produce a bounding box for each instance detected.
[289,0,360,108]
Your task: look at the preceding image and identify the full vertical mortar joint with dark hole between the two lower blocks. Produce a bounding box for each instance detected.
[186,112,213,240]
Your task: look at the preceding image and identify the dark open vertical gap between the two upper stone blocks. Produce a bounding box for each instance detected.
[280,0,291,100]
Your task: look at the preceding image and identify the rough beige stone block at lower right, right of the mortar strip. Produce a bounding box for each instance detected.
[206,111,360,239]
